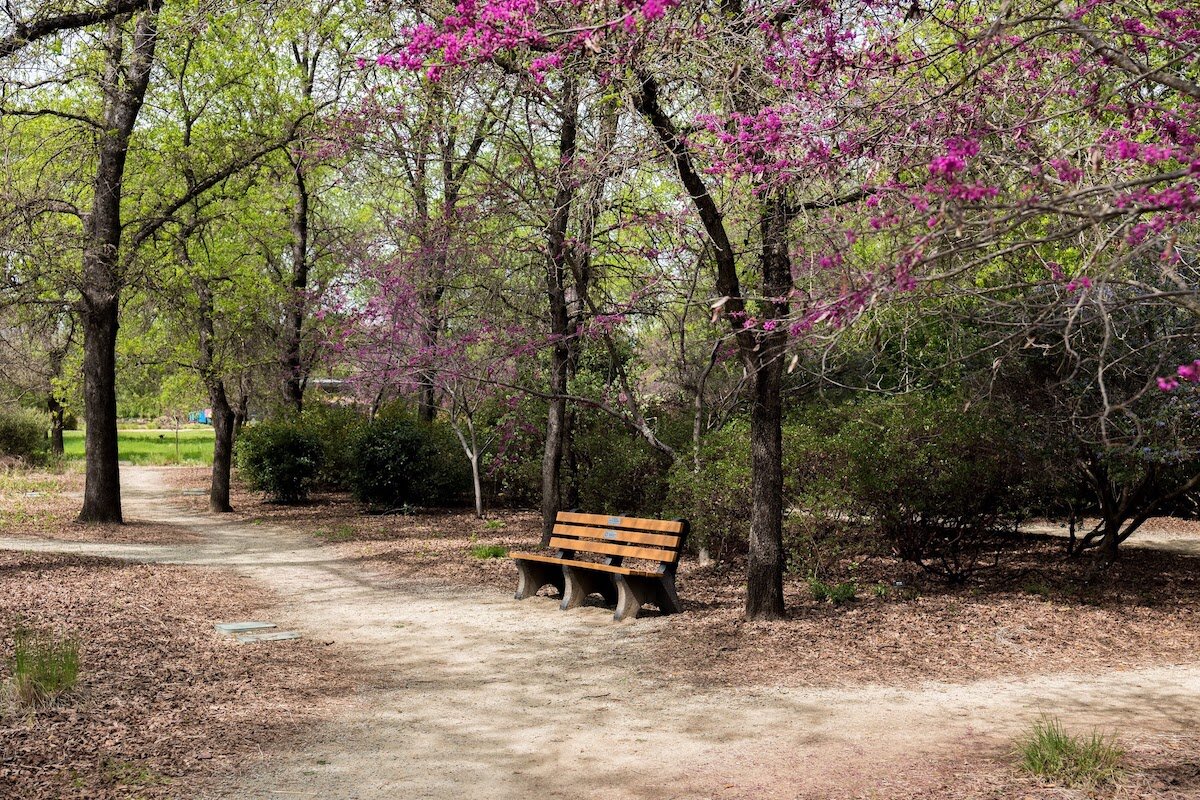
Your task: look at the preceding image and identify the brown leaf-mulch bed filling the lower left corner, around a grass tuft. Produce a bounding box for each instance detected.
[0,553,342,800]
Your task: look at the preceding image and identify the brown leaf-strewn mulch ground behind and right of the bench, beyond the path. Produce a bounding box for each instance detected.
[162,470,1200,686]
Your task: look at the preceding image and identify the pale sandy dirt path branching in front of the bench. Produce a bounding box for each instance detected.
[0,468,1200,800]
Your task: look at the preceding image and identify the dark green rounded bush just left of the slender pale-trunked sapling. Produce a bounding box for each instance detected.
[350,411,470,509]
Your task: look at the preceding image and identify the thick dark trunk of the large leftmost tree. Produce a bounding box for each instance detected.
[79,10,158,523]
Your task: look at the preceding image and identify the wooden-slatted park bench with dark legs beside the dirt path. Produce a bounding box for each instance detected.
[511,511,688,620]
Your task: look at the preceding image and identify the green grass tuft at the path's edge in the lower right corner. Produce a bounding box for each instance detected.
[1016,718,1124,789]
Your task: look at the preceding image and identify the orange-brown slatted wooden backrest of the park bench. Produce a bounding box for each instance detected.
[550,511,688,575]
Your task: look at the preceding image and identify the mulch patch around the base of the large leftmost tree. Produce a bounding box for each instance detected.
[0,465,200,545]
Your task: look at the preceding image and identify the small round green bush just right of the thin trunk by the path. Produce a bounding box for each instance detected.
[236,417,324,503]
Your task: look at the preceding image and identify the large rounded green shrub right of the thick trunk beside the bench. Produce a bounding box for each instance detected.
[838,396,1031,583]
